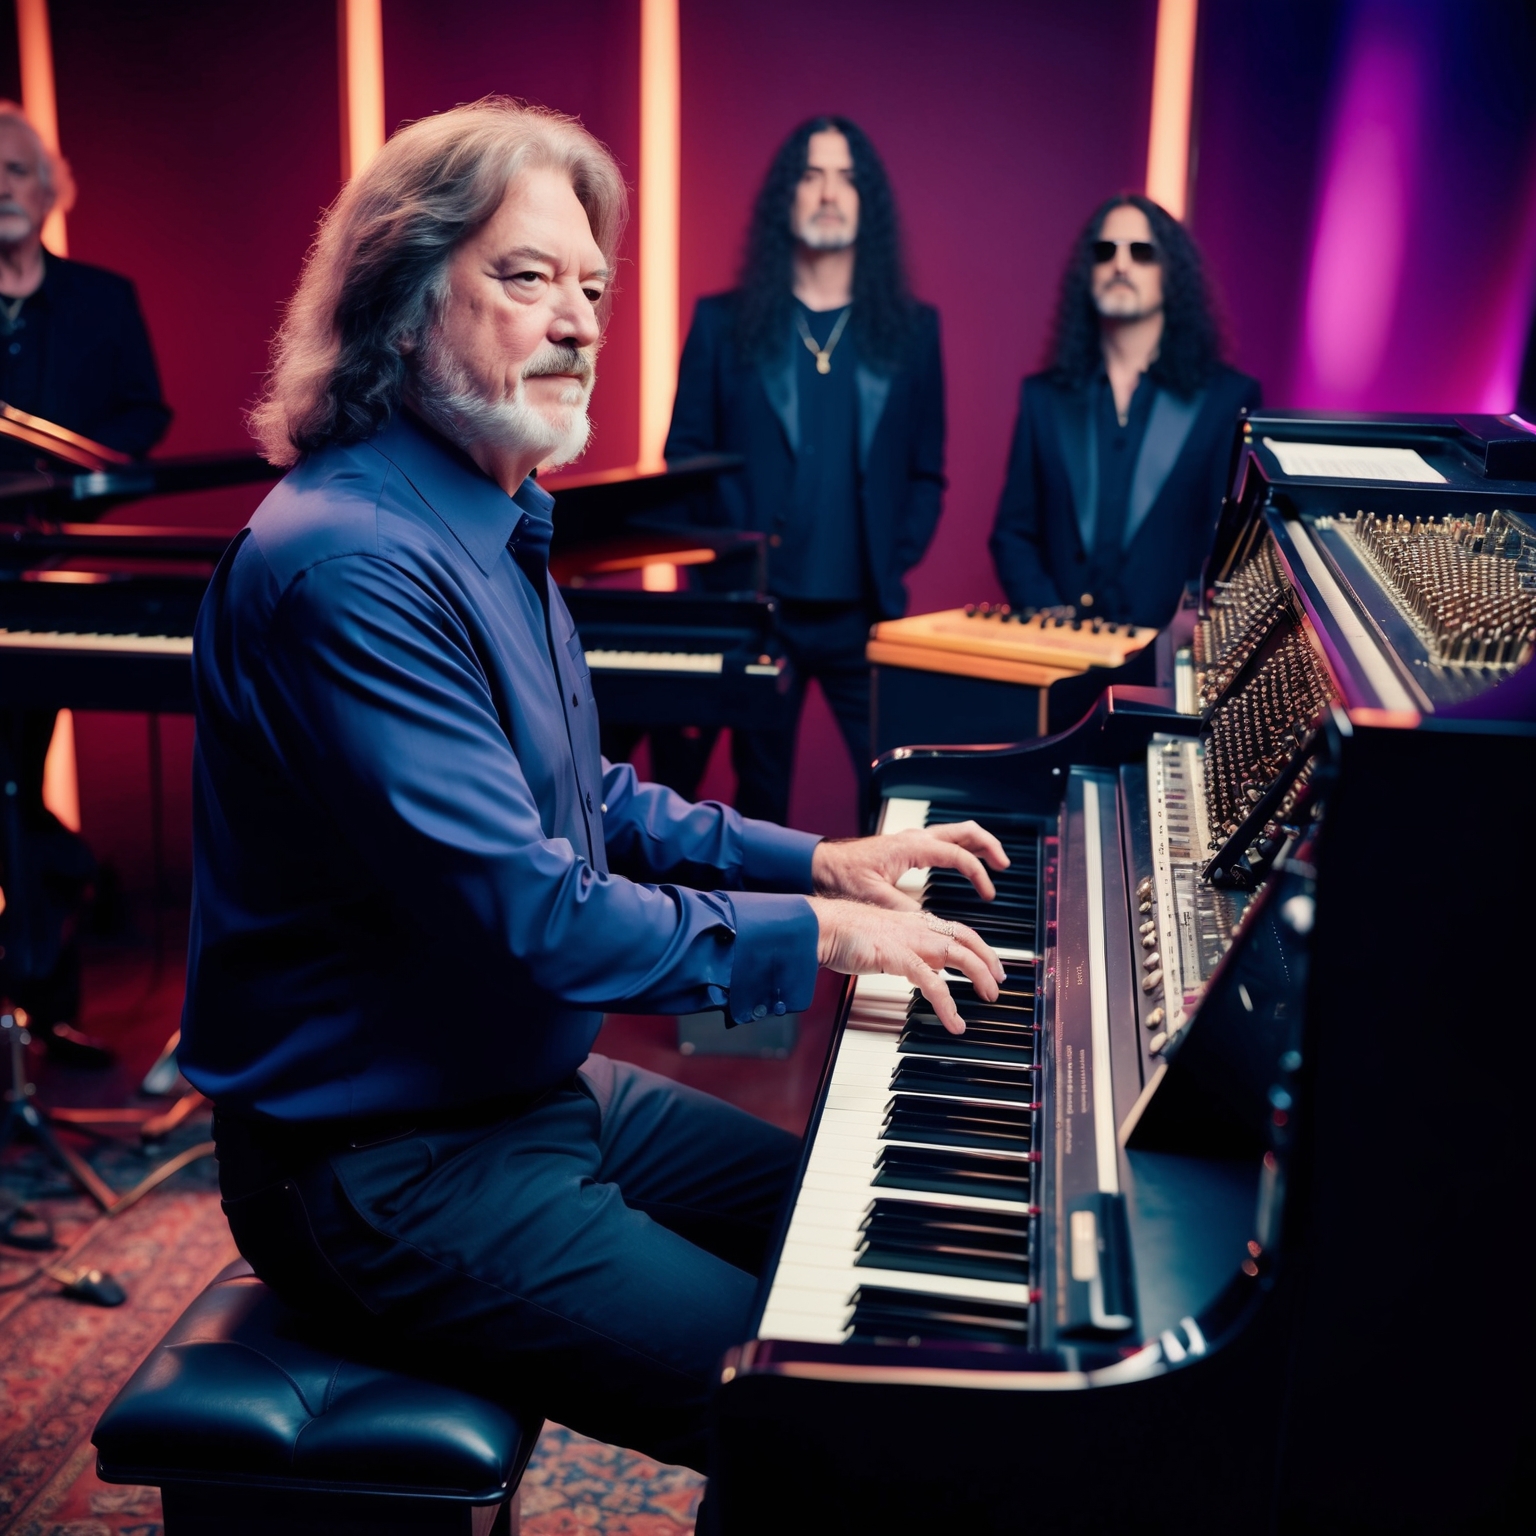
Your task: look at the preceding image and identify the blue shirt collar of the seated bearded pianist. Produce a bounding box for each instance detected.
[372,412,554,576]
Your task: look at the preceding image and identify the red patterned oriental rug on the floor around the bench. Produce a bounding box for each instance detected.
[0,1121,703,1536]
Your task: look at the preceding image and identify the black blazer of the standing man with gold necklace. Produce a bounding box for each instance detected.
[667,293,945,617]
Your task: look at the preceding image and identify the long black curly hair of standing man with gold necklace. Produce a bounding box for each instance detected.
[736,117,914,369]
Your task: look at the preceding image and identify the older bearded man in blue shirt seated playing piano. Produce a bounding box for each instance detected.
[183,100,1006,1486]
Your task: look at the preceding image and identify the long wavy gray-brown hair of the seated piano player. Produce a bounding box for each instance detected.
[247,97,628,465]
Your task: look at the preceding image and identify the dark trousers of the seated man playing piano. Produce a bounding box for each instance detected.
[215,1055,800,1470]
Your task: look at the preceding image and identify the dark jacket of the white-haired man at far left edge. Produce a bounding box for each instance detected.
[2,257,170,462]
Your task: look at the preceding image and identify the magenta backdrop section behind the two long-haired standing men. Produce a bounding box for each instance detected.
[682,0,1157,833]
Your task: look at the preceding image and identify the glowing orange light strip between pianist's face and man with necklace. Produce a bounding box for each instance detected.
[639,0,682,468]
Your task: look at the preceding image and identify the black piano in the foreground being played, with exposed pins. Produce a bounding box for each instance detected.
[711,412,1536,1536]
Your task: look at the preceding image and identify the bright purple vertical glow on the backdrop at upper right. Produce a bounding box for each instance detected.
[1298,26,1422,410]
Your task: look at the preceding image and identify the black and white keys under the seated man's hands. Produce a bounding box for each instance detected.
[759,799,1041,1344]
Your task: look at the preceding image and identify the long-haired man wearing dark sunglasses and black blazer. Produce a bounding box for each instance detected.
[991,195,1260,627]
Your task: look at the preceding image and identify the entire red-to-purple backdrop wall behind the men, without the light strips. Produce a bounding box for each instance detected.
[0,0,1536,889]
